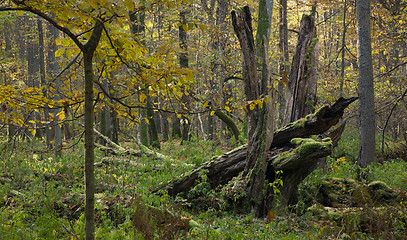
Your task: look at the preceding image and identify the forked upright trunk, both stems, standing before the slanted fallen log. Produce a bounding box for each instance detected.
[231,4,274,218]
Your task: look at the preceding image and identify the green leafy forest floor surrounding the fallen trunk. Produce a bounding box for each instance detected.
[0,126,407,239]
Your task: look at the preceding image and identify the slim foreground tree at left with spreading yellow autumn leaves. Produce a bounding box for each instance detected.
[0,0,198,239]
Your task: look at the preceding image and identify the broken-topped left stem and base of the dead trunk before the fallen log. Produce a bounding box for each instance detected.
[232,5,267,217]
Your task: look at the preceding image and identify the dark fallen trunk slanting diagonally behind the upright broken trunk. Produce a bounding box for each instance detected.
[154,98,357,196]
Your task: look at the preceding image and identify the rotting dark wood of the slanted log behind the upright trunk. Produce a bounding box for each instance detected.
[155,98,357,196]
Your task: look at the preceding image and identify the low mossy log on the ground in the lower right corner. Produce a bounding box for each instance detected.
[308,178,407,239]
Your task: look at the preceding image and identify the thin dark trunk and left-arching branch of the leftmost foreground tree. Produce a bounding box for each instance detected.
[0,1,126,240]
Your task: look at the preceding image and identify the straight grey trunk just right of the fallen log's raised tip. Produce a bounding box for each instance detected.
[356,0,376,168]
